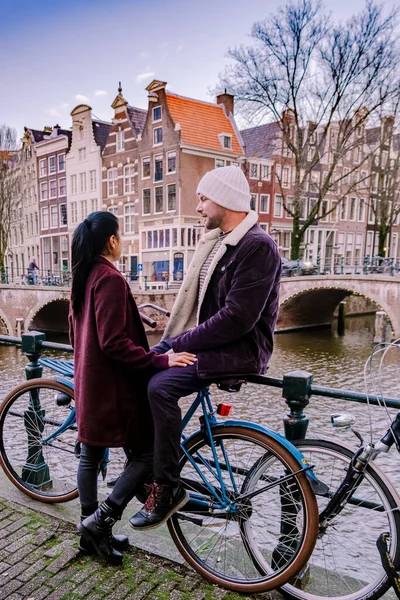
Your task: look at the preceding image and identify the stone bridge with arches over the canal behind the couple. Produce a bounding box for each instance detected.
[0,275,400,337]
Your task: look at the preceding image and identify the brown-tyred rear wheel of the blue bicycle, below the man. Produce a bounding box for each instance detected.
[168,425,318,593]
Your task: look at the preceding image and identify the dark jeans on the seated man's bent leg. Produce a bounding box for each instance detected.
[147,340,212,487]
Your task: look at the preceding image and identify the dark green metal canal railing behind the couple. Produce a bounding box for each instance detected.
[0,331,400,440]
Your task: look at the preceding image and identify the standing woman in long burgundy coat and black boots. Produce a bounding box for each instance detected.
[69,212,195,564]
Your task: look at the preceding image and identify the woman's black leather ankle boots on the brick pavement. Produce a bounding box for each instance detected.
[77,502,123,565]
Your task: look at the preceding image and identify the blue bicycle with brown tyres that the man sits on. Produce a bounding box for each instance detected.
[0,344,318,593]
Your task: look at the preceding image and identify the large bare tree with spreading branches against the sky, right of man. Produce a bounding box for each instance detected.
[220,0,399,258]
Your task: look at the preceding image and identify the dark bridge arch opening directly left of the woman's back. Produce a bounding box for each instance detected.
[25,297,69,333]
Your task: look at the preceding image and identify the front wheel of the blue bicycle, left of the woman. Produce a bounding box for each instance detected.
[0,379,79,502]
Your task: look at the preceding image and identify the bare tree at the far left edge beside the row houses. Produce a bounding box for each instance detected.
[0,124,19,275]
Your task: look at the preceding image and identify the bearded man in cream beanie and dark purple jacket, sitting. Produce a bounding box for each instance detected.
[130,166,281,529]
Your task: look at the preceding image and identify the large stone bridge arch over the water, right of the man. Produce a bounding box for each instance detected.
[277,279,394,335]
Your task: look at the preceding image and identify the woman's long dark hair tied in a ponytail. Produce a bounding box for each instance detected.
[71,211,119,315]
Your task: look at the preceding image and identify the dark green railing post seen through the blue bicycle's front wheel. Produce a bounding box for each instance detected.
[22,331,51,488]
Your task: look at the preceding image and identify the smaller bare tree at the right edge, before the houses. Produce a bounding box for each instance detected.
[368,109,400,257]
